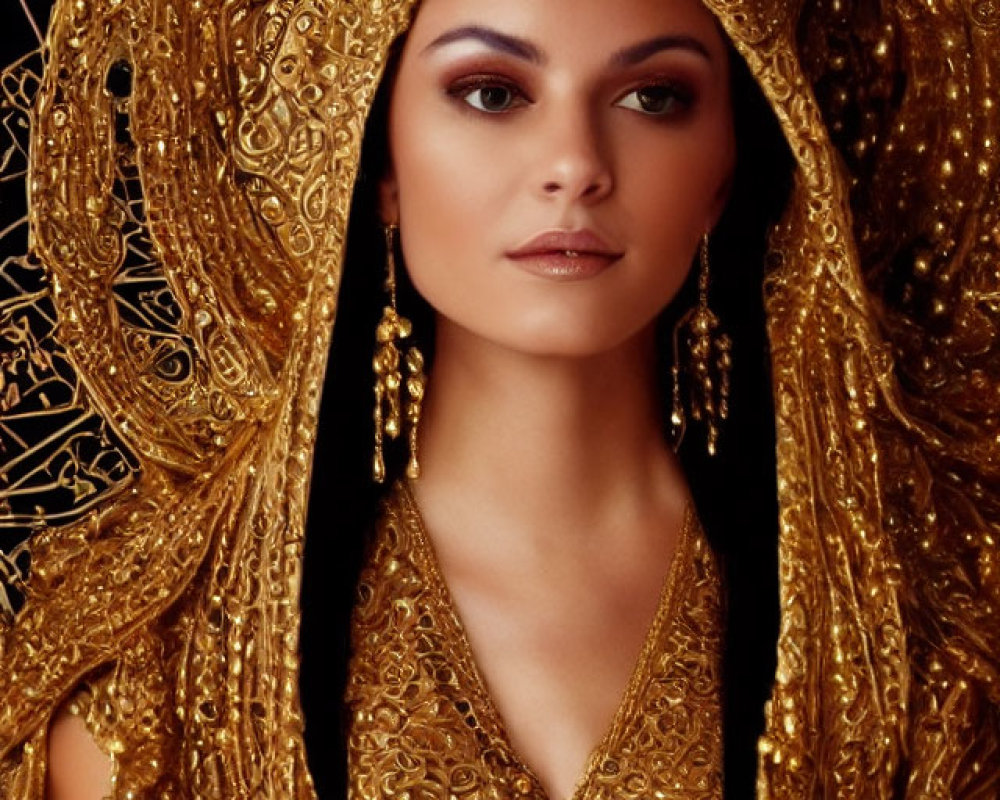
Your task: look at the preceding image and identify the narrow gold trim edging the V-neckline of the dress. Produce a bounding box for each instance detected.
[400,481,694,800]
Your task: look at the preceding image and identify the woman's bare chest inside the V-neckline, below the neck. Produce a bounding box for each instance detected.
[439,551,672,797]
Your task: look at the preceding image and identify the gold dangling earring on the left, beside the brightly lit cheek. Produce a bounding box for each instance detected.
[372,225,426,483]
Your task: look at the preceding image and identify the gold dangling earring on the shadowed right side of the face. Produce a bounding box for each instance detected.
[670,233,733,456]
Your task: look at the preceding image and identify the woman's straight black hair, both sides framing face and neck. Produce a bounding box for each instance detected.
[300,32,793,800]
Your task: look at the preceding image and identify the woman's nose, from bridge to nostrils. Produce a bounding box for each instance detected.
[538,107,614,203]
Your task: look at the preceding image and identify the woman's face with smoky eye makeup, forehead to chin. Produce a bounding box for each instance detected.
[381,0,735,356]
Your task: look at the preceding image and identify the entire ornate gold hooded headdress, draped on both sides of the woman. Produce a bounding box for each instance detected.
[0,0,1000,800]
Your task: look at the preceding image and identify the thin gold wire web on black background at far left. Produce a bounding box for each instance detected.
[0,32,135,623]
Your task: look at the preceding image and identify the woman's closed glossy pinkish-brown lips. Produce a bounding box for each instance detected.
[506,230,624,281]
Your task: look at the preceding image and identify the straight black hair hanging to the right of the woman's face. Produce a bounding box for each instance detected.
[680,48,795,798]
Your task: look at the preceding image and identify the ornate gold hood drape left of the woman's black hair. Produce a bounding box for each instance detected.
[0,0,418,798]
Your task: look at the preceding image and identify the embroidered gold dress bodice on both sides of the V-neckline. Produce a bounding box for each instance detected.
[347,485,722,800]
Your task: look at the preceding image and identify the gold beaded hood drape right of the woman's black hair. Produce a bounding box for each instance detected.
[707,0,1000,798]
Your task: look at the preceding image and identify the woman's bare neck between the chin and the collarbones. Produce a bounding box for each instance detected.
[415,320,686,536]
